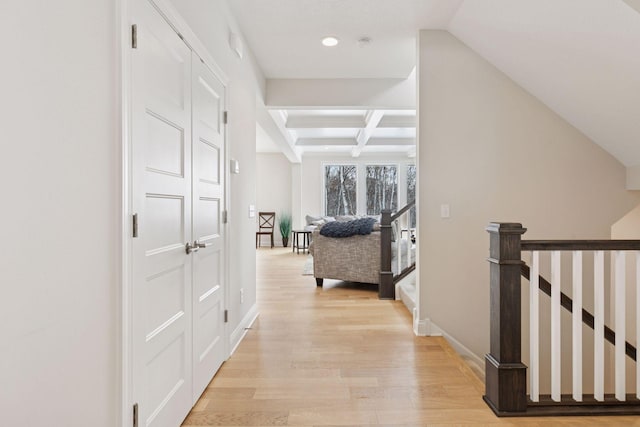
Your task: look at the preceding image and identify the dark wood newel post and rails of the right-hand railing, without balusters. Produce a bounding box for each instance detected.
[483,223,640,416]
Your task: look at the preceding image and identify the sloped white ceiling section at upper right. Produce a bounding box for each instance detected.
[448,0,640,166]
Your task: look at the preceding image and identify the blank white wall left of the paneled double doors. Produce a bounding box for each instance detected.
[0,0,121,427]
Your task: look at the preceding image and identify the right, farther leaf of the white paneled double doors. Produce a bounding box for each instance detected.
[192,54,226,403]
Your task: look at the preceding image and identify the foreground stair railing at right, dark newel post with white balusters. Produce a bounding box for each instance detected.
[483,223,640,416]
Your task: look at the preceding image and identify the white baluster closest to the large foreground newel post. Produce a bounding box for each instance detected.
[529,251,540,402]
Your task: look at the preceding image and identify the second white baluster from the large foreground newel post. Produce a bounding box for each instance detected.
[551,251,562,402]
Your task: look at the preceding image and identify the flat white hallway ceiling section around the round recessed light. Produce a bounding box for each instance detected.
[229,0,462,79]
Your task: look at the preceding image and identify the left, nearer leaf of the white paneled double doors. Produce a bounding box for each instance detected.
[131,0,193,427]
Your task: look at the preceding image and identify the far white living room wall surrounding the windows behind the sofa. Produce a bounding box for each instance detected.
[295,154,415,227]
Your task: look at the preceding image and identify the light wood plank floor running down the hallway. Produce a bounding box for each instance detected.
[183,248,640,427]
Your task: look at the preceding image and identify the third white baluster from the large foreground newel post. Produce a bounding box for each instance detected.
[571,251,582,402]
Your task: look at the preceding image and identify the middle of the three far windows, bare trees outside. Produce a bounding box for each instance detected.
[366,165,398,215]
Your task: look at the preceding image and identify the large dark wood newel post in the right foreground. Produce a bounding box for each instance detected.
[484,222,527,415]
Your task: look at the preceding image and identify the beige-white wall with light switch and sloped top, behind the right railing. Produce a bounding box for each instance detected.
[417,30,639,364]
